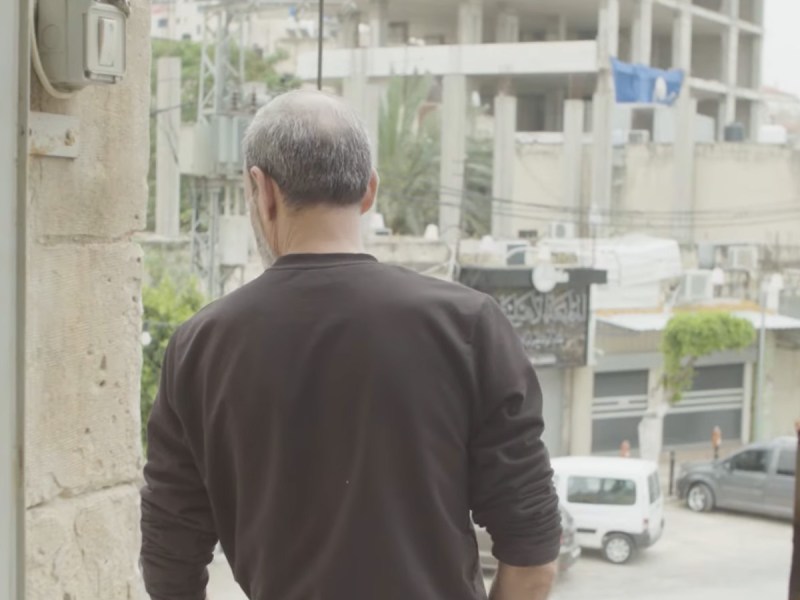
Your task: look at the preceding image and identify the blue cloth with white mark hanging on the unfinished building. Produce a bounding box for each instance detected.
[611,58,685,104]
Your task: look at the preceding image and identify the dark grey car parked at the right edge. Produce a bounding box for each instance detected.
[677,437,797,519]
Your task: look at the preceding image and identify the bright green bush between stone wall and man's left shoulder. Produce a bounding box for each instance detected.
[141,265,206,443]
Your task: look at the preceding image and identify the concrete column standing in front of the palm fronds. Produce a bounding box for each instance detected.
[439,75,467,242]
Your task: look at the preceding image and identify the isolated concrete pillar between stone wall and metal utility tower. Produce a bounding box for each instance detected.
[156,58,181,238]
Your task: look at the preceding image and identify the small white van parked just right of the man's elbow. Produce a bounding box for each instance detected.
[553,456,664,564]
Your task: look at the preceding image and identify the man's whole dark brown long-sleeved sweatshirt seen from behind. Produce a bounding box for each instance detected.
[142,254,560,600]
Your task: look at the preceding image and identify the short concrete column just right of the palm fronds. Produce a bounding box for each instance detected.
[492,92,517,239]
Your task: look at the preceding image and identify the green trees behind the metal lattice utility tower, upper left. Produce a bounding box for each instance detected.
[147,39,300,231]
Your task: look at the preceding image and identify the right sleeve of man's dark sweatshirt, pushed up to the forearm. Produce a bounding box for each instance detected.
[469,299,561,567]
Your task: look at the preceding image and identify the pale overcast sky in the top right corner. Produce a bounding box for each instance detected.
[764,0,800,96]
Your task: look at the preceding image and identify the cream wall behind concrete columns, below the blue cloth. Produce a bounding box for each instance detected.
[514,144,800,244]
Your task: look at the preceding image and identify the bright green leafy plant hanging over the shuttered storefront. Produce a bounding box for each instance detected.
[661,312,756,404]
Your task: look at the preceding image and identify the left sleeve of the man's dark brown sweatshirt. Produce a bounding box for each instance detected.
[141,338,217,600]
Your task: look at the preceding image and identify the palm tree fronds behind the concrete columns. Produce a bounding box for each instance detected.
[378,75,494,236]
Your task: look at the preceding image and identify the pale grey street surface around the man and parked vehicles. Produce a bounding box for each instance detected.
[209,502,792,600]
